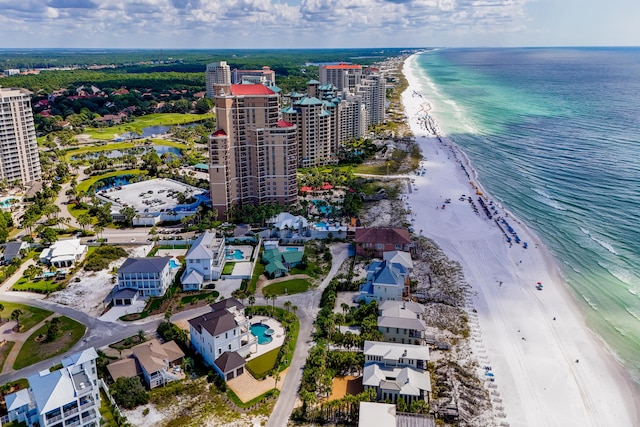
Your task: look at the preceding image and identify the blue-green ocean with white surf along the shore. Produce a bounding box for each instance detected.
[410,48,640,384]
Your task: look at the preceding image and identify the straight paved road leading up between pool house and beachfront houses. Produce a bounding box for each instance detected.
[267,243,351,427]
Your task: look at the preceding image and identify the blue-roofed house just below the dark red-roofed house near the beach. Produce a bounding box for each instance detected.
[360,261,409,303]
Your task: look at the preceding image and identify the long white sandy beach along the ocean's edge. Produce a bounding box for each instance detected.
[402,56,640,427]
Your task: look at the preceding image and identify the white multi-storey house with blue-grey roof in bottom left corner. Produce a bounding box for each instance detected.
[6,347,100,427]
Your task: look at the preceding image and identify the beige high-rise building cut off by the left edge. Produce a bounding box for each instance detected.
[0,87,42,184]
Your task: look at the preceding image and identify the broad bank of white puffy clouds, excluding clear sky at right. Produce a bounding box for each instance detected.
[0,0,528,48]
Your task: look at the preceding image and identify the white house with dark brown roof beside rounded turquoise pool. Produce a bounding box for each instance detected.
[189,298,258,376]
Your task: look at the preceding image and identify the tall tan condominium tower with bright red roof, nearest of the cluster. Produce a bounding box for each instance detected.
[209,84,298,217]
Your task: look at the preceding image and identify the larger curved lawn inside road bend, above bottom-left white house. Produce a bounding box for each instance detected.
[13,316,87,370]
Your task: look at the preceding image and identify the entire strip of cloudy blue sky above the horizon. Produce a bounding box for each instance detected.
[0,0,640,49]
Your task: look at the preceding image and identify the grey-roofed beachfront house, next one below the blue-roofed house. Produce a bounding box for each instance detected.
[378,301,427,345]
